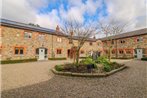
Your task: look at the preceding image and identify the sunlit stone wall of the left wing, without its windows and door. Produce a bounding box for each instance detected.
[0,26,102,60]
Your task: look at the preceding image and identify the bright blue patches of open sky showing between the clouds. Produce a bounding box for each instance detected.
[38,0,108,22]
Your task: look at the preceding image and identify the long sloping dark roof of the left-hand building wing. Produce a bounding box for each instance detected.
[0,19,65,36]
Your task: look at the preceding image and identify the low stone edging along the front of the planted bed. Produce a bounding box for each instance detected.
[51,65,128,77]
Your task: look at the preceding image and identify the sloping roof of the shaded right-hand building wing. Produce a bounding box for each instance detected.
[99,28,147,41]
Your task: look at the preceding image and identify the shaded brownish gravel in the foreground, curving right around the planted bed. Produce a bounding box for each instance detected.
[2,60,147,98]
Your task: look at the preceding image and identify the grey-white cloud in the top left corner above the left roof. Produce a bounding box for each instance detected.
[2,0,36,23]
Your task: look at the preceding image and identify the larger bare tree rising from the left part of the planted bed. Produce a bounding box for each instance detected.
[61,20,98,65]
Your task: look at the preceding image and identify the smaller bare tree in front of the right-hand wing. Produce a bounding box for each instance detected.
[98,20,127,61]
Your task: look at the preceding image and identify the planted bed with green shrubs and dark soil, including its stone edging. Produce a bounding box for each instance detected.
[52,57,126,76]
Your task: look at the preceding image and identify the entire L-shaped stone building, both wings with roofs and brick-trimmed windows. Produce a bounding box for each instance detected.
[0,19,147,60]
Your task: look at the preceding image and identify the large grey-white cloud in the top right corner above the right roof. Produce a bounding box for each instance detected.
[105,0,147,30]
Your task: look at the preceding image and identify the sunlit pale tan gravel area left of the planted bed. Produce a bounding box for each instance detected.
[1,60,70,90]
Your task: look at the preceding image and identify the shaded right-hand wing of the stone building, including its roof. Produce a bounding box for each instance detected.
[100,28,147,59]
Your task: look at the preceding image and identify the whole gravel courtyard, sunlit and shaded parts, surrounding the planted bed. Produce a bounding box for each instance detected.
[2,60,147,98]
